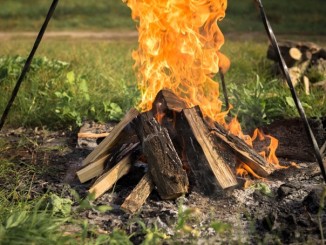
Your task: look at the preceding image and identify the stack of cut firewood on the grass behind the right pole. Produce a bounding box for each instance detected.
[267,41,326,94]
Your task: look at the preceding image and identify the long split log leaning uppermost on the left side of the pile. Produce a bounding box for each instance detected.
[83,109,139,166]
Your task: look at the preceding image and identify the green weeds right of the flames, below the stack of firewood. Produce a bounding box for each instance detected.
[229,75,326,129]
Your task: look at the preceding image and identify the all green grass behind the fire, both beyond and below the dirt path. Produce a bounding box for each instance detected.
[0,0,326,128]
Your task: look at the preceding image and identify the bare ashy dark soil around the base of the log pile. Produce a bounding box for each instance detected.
[0,123,326,244]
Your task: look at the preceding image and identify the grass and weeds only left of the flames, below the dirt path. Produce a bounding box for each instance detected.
[0,40,138,128]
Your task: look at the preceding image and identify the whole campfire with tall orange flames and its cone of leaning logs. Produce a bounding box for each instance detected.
[77,0,284,213]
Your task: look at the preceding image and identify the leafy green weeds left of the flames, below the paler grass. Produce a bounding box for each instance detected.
[0,43,137,128]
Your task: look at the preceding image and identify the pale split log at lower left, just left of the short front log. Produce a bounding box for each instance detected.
[89,154,132,199]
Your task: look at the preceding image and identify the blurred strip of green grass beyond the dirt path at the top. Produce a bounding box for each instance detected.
[0,0,326,35]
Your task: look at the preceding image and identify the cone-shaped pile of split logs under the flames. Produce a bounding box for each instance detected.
[77,90,275,213]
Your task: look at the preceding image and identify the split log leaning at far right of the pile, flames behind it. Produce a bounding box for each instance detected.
[208,114,275,177]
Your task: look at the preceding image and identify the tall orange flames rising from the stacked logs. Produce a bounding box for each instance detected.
[126,0,281,178]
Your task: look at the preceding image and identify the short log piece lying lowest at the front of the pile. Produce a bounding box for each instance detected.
[121,172,154,214]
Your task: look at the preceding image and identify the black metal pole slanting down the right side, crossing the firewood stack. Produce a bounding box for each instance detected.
[256,0,326,182]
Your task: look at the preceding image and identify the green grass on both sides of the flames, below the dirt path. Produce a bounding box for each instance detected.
[0,39,326,128]
